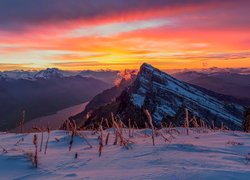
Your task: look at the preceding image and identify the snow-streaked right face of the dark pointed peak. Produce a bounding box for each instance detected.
[131,64,245,128]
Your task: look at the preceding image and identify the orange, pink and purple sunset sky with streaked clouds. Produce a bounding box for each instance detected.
[0,0,250,70]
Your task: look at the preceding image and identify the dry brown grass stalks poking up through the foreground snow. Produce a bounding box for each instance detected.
[3,109,250,172]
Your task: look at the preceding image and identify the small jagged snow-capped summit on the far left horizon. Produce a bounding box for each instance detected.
[34,68,63,79]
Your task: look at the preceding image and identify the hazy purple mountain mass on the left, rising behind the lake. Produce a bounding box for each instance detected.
[0,69,111,130]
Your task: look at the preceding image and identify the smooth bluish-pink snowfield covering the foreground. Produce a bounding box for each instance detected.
[0,128,250,180]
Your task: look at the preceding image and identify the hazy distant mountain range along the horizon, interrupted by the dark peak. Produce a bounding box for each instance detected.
[0,67,250,100]
